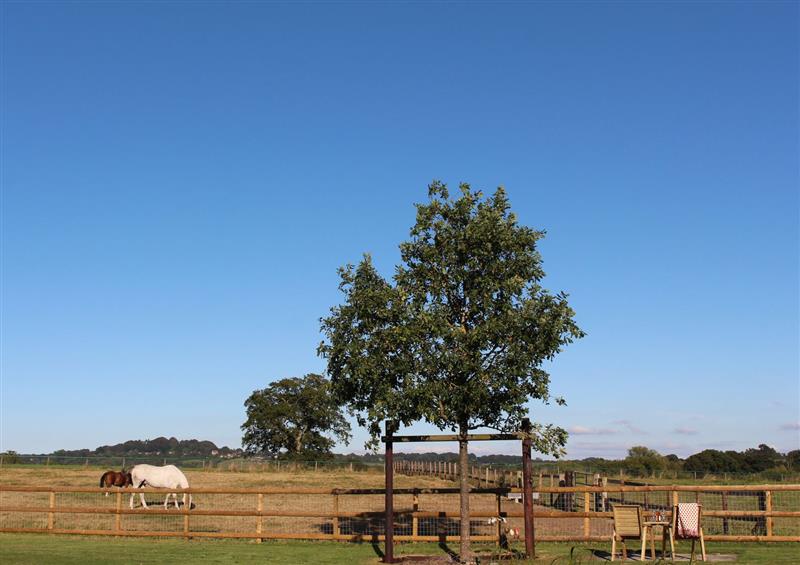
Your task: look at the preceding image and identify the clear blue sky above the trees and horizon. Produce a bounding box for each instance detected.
[0,2,800,457]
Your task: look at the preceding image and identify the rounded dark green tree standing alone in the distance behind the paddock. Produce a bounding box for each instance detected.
[242,373,350,458]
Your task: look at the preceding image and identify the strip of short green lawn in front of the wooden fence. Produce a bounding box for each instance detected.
[0,534,800,565]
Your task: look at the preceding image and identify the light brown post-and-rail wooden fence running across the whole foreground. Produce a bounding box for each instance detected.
[0,485,800,543]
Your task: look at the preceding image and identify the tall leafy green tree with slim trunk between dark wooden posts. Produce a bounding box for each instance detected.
[319,182,583,558]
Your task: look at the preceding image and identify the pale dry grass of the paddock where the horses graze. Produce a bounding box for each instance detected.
[0,466,506,535]
